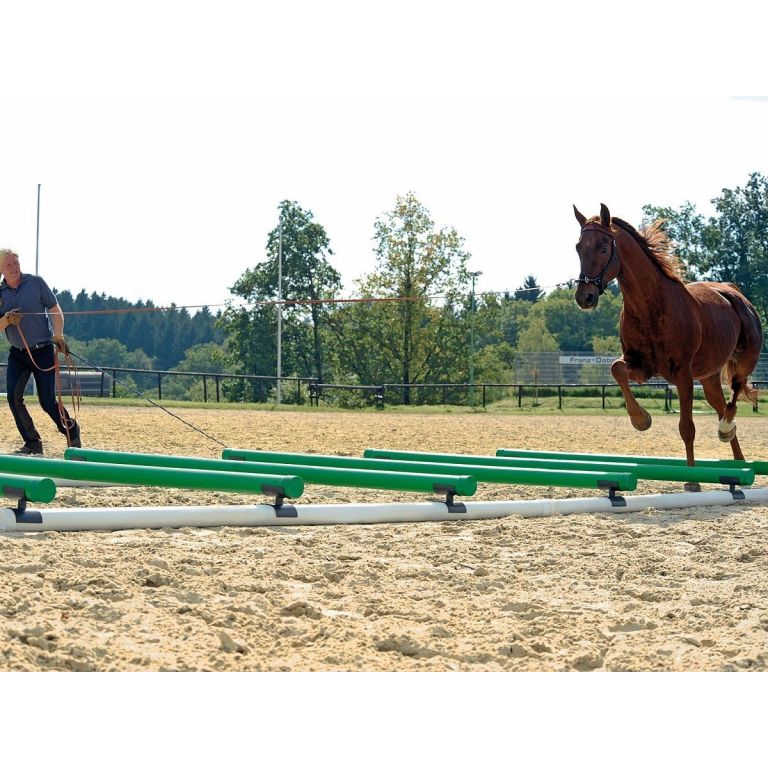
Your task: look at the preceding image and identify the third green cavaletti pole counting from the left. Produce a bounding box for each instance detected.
[64,448,477,496]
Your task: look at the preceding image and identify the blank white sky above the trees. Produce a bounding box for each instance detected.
[0,0,768,306]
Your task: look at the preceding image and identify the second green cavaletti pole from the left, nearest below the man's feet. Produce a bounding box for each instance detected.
[0,456,304,499]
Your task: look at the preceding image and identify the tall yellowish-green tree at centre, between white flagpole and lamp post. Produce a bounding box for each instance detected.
[333,193,470,402]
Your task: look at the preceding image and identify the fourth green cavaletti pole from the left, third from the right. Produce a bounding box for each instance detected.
[221,448,637,491]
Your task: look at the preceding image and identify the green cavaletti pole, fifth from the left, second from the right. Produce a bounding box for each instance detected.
[365,448,755,485]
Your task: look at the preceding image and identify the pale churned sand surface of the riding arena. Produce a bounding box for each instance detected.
[0,405,768,671]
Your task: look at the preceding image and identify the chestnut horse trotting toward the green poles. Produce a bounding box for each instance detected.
[573,205,763,480]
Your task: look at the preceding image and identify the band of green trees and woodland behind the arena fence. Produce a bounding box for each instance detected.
[24,173,768,399]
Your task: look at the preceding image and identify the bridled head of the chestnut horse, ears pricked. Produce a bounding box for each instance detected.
[573,204,619,309]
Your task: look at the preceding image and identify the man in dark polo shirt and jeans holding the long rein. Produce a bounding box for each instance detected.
[0,249,81,456]
